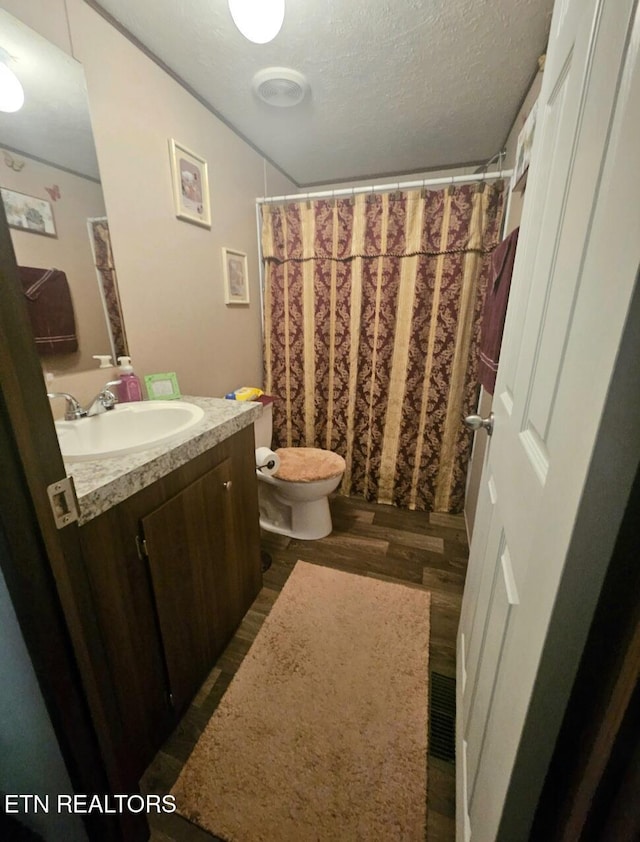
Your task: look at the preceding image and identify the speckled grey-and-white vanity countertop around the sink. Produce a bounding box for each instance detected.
[65,397,262,525]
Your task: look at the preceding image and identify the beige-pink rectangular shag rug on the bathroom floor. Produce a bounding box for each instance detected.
[172,561,430,842]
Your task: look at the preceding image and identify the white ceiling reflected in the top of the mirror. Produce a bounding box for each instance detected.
[0,9,99,179]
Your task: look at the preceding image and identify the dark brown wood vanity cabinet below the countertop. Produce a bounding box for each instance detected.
[80,426,262,786]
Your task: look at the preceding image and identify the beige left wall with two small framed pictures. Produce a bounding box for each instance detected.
[2,0,296,400]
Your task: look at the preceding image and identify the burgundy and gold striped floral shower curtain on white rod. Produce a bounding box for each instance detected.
[262,182,503,512]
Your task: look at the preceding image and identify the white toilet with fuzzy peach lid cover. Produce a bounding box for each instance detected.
[254,397,345,541]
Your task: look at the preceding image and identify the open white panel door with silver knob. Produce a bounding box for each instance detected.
[457,0,640,842]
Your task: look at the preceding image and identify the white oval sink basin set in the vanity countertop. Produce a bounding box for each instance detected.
[56,401,204,462]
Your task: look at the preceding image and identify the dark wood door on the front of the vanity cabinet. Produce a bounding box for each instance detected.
[142,458,234,711]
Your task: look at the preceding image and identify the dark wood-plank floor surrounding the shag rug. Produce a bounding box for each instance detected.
[142,497,468,842]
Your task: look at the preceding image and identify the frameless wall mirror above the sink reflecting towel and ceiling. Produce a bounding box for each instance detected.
[0,9,128,374]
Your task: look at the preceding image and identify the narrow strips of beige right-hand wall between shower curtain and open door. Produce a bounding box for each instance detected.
[464,65,542,538]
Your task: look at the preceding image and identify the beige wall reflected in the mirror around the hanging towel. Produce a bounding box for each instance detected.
[1,150,111,373]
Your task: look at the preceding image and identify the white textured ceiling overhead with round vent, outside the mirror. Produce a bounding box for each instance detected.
[95,0,553,186]
